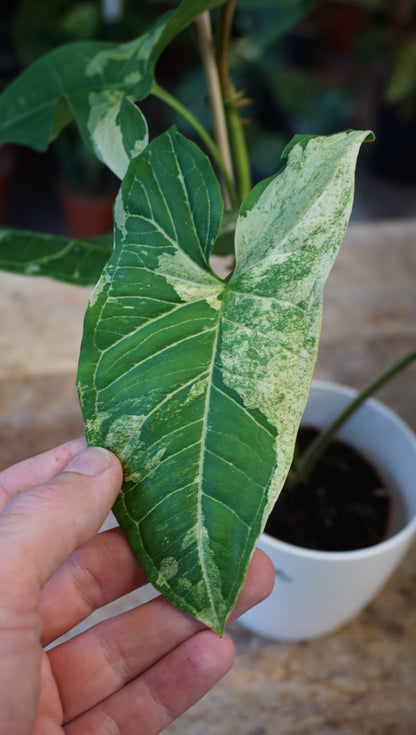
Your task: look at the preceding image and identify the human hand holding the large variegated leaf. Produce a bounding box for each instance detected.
[0,439,274,735]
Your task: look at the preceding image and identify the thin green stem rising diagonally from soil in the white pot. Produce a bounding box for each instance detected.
[295,350,416,483]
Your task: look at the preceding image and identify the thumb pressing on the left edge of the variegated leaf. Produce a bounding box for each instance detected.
[0,449,122,732]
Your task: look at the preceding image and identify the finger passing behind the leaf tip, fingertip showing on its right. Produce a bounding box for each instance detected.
[49,550,274,720]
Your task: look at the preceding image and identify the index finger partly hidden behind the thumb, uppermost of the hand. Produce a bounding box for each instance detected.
[0,438,86,512]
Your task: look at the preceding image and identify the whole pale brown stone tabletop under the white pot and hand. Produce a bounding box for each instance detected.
[0,220,416,735]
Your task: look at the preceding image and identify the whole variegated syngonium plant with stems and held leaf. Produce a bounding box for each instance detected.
[0,0,371,633]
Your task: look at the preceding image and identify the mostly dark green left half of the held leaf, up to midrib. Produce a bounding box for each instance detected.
[78,131,231,628]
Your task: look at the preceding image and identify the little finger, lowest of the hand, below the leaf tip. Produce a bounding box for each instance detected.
[65,630,234,735]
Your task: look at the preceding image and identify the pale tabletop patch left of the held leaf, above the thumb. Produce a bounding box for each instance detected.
[0,273,89,468]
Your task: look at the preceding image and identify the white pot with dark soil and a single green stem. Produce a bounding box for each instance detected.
[241,350,416,640]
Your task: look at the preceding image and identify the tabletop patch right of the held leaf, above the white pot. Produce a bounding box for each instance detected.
[315,220,416,430]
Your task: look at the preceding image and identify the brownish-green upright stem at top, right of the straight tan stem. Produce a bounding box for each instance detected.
[216,0,251,201]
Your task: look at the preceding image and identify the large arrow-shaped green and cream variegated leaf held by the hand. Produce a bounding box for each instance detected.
[78,130,367,632]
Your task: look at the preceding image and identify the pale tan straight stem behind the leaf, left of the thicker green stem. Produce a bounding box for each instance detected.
[195,10,234,208]
